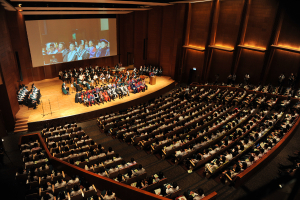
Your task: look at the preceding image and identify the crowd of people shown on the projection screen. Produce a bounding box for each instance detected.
[42,39,110,64]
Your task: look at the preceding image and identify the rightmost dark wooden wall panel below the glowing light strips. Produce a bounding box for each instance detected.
[267,49,300,85]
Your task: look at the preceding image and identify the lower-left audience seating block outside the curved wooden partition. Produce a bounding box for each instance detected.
[16,135,116,200]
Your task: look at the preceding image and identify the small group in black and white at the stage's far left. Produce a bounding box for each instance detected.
[17,83,41,109]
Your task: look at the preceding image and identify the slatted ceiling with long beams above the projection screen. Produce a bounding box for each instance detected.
[0,0,199,18]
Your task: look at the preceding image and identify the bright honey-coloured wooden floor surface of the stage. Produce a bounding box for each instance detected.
[16,76,175,123]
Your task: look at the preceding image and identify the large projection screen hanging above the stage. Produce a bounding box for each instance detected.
[25,18,117,67]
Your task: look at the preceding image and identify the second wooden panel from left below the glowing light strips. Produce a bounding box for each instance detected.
[208,49,233,83]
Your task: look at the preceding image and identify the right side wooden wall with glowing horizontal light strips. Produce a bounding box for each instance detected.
[180,0,300,85]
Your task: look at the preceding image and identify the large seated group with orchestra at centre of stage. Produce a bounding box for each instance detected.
[59,63,162,106]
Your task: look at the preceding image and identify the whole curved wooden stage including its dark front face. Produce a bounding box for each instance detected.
[16,76,175,131]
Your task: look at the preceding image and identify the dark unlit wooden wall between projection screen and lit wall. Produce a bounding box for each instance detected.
[119,4,186,78]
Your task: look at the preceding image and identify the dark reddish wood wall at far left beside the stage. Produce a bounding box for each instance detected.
[0,5,19,131]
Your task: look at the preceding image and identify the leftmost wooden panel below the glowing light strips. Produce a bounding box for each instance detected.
[182,49,204,82]
